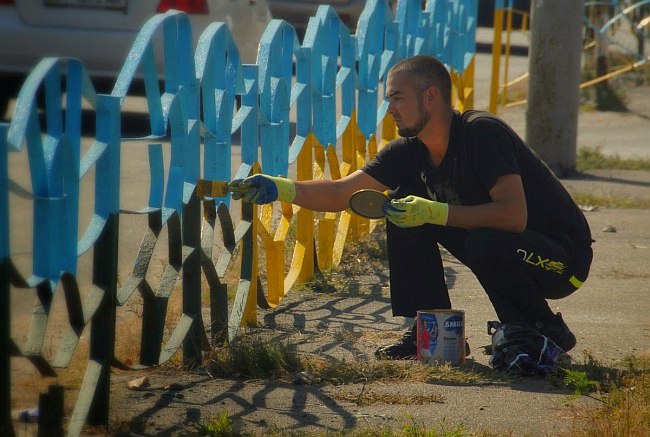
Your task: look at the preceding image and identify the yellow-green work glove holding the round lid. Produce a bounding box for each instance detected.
[384,196,449,228]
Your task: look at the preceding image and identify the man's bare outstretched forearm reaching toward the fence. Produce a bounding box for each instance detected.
[293,170,388,211]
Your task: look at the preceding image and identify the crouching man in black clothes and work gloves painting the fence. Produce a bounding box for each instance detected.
[225,55,592,359]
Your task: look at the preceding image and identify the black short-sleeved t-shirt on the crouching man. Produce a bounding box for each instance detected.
[362,111,591,244]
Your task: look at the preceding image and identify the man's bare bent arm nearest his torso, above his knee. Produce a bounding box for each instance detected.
[447,174,528,232]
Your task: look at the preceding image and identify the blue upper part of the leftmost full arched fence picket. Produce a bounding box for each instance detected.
[9,58,88,282]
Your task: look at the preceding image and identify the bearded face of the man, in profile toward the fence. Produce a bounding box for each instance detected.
[386,73,431,137]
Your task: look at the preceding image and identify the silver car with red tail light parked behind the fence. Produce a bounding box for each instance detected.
[0,0,271,119]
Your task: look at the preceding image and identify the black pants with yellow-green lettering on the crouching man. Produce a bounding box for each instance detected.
[387,222,592,324]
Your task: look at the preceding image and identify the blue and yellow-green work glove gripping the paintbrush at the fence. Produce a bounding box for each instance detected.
[228,174,296,205]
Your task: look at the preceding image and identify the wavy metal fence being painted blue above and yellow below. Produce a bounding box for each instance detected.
[0,0,477,435]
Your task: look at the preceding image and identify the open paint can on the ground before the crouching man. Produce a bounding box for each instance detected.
[417,310,465,364]
